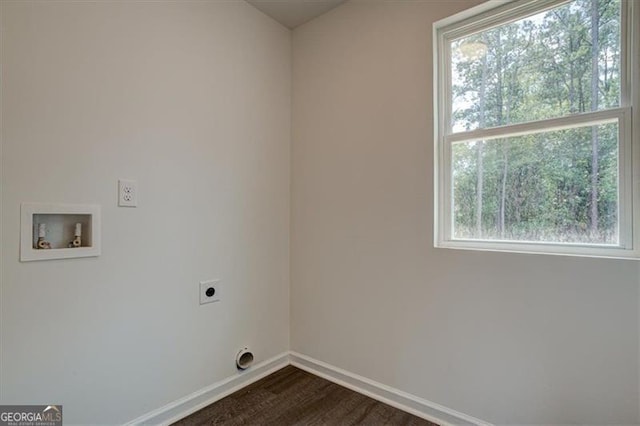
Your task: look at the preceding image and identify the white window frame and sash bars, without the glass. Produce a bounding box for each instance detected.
[433,0,640,259]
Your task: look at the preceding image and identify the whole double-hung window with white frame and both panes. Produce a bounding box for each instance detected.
[434,0,640,258]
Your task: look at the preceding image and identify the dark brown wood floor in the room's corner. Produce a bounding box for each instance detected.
[174,366,435,426]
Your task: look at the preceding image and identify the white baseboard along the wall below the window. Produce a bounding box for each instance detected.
[289,352,491,426]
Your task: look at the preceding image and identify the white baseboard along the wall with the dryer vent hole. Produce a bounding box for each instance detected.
[125,352,289,426]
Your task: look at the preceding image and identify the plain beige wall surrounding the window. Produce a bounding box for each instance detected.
[291,1,638,424]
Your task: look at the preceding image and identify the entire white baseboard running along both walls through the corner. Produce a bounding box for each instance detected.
[125,352,491,426]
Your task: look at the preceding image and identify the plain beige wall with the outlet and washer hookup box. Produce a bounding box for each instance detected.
[0,1,291,424]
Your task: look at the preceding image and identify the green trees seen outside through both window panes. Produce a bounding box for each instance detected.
[452,0,620,242]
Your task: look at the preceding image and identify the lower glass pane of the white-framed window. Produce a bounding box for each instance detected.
[452,122,618,245]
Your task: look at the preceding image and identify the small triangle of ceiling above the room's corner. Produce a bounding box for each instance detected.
[247,0,346,29]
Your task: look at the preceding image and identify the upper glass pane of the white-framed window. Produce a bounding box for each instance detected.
[450,0,620,132]
